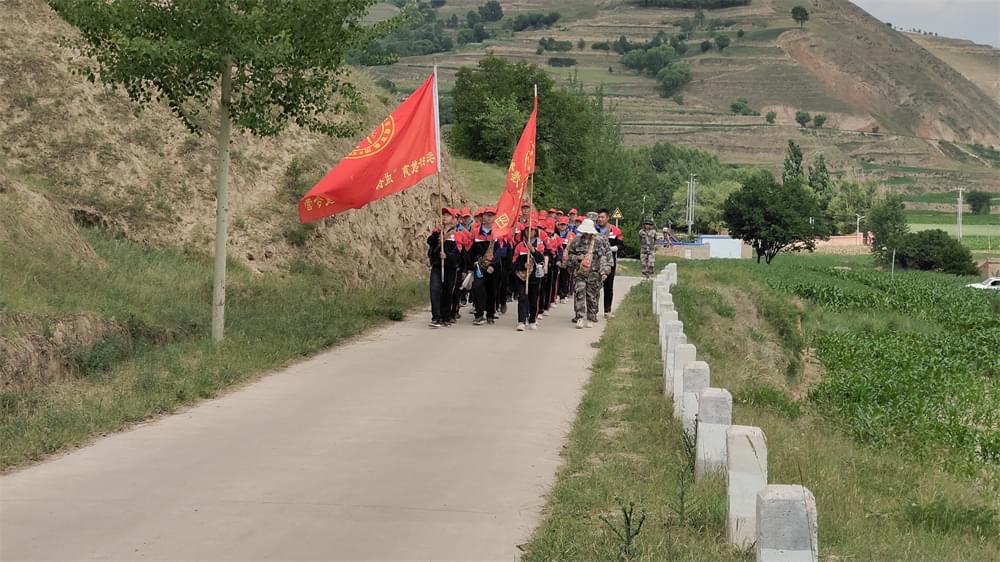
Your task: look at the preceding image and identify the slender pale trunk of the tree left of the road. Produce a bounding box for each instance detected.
[212,56,233,343]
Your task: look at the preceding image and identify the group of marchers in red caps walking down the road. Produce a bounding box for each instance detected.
[427,204,623,331]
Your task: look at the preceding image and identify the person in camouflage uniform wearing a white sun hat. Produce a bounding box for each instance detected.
[566,215,614,328]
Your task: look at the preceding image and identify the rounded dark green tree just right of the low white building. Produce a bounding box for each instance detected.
[723,174,827,265]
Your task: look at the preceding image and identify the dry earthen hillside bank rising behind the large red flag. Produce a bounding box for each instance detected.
[0,0,464,283]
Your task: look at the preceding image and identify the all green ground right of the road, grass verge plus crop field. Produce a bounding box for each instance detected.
[524,256,1000,562]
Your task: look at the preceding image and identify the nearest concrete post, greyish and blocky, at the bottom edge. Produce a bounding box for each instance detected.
[757,485,819,562]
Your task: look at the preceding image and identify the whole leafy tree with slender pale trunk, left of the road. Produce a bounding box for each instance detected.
[49,0,402,342]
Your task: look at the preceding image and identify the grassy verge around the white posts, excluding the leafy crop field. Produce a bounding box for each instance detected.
[525,270,1000,562]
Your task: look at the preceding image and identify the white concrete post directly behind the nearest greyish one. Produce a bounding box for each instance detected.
[726,425,767,548]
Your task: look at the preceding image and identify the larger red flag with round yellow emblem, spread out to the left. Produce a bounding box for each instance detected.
[299,75,441,224]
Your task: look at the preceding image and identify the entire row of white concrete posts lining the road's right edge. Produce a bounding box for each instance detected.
[653,263,819,562]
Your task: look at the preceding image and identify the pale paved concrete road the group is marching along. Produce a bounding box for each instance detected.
[0,278,635,561]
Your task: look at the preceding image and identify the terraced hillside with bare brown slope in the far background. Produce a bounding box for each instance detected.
[372,0,1000,195]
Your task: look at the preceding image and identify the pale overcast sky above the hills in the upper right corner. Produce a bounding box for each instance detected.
[851,0,1000,47]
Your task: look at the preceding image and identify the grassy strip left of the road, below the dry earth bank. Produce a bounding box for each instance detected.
[0,231,425,469]
